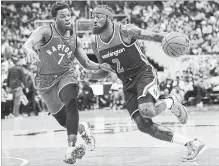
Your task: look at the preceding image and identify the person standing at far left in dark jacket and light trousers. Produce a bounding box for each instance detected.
[7,56,28,117]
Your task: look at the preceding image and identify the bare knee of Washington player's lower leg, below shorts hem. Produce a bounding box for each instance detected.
[134,114,153,134]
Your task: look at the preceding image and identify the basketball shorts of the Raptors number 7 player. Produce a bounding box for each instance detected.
[35,70,78,114]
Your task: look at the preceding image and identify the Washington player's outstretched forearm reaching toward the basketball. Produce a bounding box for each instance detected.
[133,30,168,42]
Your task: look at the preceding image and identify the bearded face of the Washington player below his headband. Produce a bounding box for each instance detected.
[92,13,108,34]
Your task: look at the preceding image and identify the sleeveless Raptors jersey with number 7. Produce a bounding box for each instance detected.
[37,24,77,75]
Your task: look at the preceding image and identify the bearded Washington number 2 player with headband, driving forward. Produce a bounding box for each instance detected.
[91,5,205,161]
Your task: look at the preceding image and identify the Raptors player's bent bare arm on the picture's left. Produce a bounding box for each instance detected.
[22,25,51,63]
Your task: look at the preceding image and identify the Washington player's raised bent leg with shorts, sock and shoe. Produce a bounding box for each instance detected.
[136,70,188,124]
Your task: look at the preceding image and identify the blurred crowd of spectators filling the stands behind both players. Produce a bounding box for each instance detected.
[1,0,219,116]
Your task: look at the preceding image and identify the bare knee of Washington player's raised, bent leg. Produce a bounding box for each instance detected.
[138,103,156,118]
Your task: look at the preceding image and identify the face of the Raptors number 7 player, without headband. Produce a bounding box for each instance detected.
[56,8,71,29]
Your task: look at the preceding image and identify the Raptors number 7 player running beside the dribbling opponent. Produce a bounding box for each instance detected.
[23,2,109,164]
